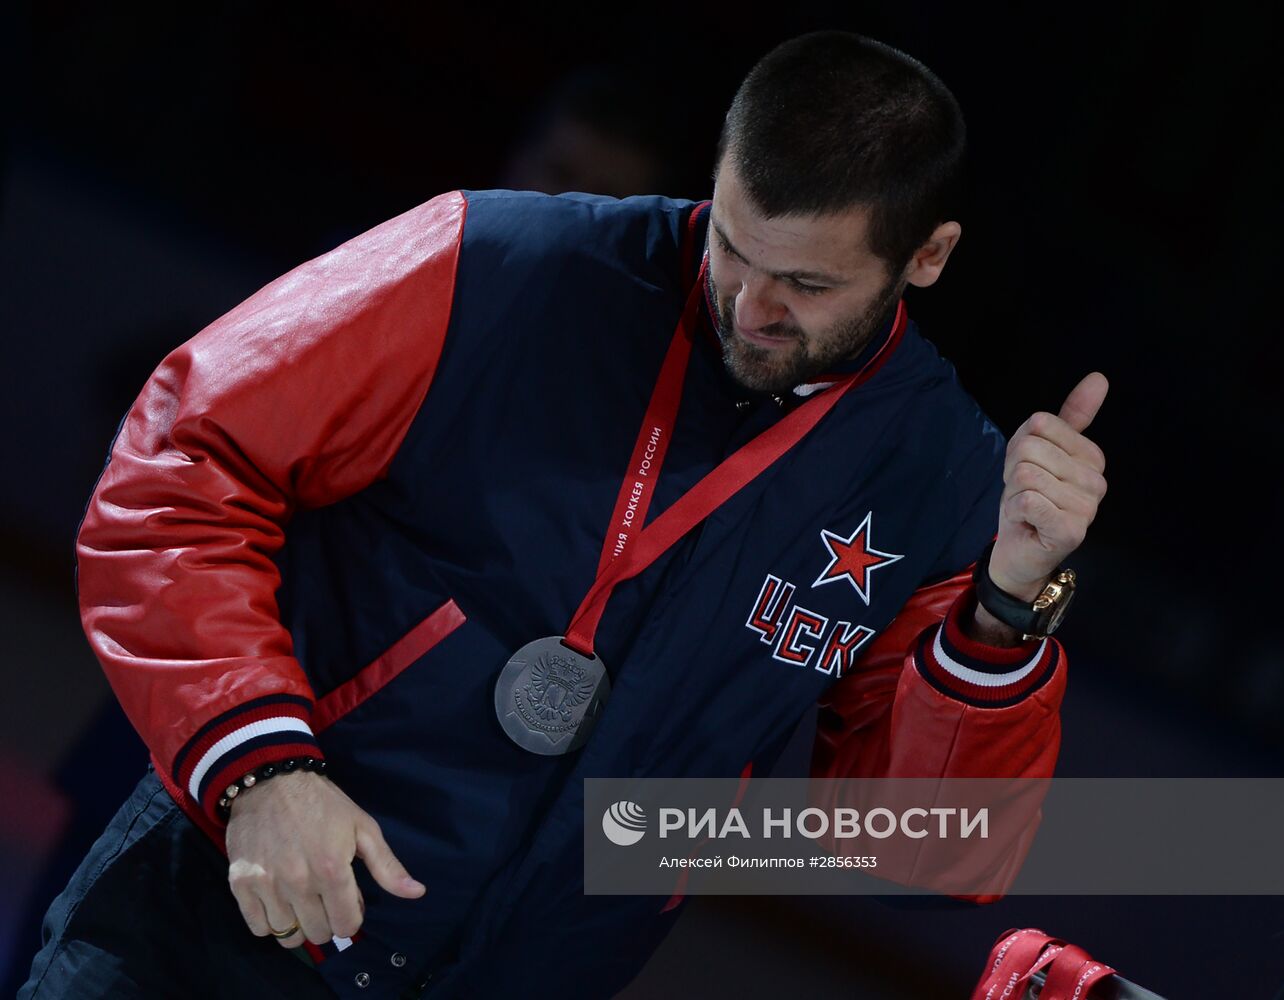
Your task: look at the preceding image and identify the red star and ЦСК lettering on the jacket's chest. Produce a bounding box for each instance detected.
[745,511,904,678]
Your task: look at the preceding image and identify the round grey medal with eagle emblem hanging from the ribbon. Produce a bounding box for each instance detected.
[494,635,611,756]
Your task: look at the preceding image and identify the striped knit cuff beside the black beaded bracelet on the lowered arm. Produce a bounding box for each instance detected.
[171,694,325,827]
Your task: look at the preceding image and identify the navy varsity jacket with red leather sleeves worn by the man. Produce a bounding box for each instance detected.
[77,191,1066,997]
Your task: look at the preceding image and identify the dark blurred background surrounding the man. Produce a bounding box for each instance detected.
[0,0,1284,997]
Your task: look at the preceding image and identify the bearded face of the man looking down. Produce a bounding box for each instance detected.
[709,155,905,393]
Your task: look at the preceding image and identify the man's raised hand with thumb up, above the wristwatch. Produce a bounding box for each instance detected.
[990,371,1109,599]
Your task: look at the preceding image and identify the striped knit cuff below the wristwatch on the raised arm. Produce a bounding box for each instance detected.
[914,584,1061,709]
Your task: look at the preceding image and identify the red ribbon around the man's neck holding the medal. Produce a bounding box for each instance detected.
[564,258,905,657]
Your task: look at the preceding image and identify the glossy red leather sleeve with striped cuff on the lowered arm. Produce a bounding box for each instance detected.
[76,191,466,823]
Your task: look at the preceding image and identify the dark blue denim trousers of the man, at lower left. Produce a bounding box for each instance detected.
[18,769,334,1000]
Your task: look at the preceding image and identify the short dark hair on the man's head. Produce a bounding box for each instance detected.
[714,31,967,275]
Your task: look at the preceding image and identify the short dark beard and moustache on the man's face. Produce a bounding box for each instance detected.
[707,271,905,395]
